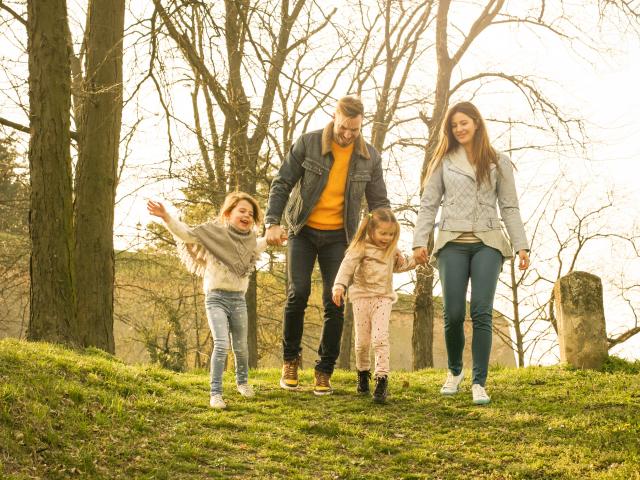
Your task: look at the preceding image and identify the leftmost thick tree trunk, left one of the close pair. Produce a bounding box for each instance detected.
[27,0,75,344]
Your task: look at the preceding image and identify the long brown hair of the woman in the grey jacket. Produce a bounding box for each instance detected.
[425,102,498,184]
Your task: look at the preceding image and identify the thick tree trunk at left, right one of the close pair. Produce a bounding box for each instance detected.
[75,0,124,353]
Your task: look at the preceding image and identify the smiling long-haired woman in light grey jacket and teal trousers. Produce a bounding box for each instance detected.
[413,102,529,405]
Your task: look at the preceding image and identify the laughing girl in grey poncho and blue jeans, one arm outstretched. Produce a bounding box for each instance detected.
[147,192,266,409]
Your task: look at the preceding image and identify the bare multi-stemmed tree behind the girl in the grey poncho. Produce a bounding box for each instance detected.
[148,0,335,366]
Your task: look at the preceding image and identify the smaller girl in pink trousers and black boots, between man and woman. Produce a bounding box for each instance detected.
[332,208,415,403]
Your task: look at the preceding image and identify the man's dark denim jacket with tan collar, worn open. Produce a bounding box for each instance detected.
[265,122,389,241]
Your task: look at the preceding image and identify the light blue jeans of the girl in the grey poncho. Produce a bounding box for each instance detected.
[205,290,249,395]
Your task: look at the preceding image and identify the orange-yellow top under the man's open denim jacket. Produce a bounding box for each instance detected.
[307,142,354,230]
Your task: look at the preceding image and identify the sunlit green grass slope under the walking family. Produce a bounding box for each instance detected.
[0,340,640,479]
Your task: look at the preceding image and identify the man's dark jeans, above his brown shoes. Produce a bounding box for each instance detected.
[282,226,347,374]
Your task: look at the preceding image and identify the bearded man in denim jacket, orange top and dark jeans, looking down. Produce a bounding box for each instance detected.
[265,96,389,395]
